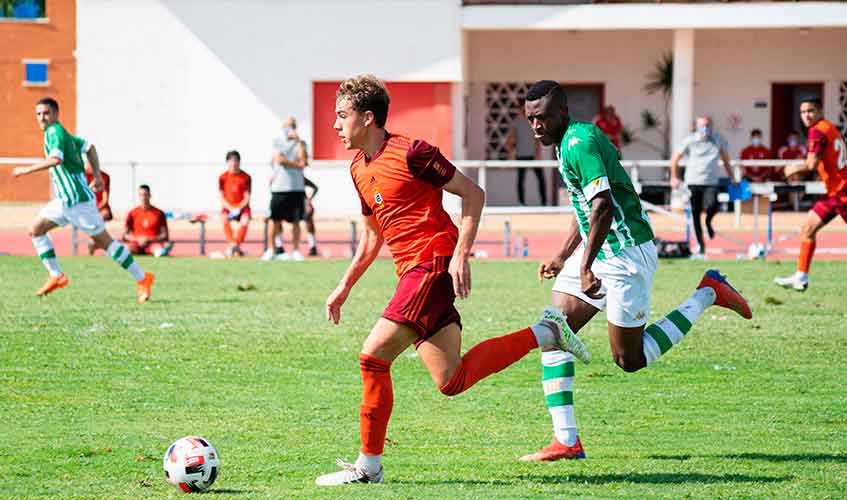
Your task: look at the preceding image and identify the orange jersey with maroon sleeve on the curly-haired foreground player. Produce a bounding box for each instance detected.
[350,132,459,276]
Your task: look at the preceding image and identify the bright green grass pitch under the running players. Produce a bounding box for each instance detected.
[0,257,847,499]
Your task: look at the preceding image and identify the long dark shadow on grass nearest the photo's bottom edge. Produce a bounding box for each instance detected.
[392,472,792,486]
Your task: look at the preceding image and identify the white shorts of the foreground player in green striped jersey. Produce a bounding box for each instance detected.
[553,241,658,328]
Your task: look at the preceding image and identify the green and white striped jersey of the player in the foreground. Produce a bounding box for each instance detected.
[556,119,654,260]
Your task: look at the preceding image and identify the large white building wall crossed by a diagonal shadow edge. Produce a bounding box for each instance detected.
[77,0,461,213]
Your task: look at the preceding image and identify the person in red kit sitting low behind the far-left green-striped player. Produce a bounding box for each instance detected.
[123,184,173,257]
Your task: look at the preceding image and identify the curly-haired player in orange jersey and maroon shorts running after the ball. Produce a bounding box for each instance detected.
[315,75,590,486]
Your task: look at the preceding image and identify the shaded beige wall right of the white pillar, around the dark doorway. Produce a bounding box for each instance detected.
[694,28,847,158]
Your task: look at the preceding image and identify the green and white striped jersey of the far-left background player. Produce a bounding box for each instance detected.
[44,122,94,207]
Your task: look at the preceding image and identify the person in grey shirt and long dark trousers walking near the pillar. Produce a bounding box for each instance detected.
[671,116,733,259]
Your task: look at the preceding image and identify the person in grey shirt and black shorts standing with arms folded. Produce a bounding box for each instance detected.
[262,116,306,261]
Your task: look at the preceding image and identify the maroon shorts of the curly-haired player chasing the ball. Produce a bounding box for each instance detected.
[382,257,462,347]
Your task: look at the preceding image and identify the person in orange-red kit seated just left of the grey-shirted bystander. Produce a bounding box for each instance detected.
[218,150,252,257]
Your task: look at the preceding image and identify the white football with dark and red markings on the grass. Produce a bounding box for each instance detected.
[162,436,221,493]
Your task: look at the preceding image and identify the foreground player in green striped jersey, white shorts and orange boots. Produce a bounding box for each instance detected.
[521,80,752,461]
